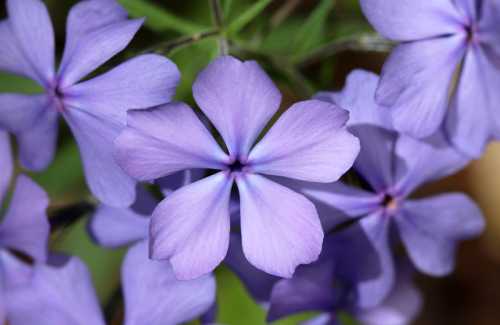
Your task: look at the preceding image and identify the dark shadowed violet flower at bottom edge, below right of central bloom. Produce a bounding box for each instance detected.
[268,224,421,325]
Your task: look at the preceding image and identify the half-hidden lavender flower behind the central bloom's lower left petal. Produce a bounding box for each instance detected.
[89,174,216,325]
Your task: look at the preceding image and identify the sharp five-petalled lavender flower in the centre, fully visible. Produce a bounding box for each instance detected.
[115,56,359,279]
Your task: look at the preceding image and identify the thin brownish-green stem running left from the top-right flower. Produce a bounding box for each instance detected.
[298,34,394,68]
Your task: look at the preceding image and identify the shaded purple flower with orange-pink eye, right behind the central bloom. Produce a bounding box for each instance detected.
[296,71,484,304]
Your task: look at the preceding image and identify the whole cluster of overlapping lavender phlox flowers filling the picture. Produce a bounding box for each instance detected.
[0,0,492,325]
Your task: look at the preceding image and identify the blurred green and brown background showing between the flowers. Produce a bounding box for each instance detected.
[0,0,500,325]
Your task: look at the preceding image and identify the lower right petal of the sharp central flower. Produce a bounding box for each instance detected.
[236,174,323,278]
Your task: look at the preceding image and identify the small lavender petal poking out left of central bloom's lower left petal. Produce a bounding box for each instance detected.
[89,188,156,248]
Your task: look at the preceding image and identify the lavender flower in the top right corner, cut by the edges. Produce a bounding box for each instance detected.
[361,0,500,157]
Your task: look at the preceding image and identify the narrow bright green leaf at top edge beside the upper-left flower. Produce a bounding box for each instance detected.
[119,0,208,34]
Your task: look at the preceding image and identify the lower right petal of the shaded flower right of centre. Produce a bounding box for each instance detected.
[395,193,485,276]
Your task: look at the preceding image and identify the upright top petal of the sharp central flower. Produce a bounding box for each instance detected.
[193,56,281,157]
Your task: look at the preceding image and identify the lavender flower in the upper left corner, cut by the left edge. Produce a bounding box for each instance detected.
[0,0,179,206]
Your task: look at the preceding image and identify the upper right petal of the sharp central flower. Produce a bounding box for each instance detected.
[248,100,359,183]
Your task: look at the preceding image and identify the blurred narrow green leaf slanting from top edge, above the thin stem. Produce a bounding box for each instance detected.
[293,0,334,57]
